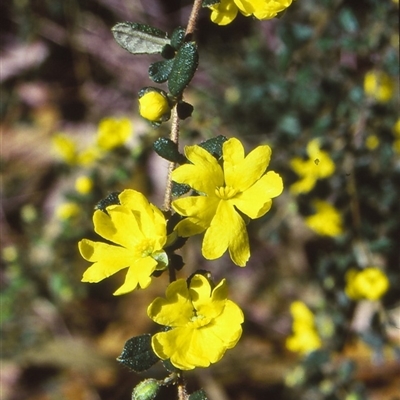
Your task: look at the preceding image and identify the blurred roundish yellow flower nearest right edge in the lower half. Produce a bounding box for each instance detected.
[345,267,389,300]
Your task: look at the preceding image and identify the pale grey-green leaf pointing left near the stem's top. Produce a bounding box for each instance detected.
[111,22,170,54]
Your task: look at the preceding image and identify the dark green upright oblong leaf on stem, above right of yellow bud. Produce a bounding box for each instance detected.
[168,42,199,96]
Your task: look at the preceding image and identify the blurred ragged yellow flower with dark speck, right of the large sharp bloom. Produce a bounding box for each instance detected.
[290,139,335,194]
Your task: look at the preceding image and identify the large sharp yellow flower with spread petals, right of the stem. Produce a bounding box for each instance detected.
[172,138,283,266]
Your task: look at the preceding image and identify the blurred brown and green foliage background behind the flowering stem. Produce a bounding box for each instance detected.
[0,0,400,400]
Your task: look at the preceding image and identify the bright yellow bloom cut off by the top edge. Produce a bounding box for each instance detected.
[210,0,292,25]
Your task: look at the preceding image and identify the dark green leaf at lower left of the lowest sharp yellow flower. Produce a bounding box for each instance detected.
[117,333,160,372]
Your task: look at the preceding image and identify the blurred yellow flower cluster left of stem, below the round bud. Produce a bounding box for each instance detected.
[53,118,132,166]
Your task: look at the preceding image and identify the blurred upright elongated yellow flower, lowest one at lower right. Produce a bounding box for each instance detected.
[286,301,322,354]
